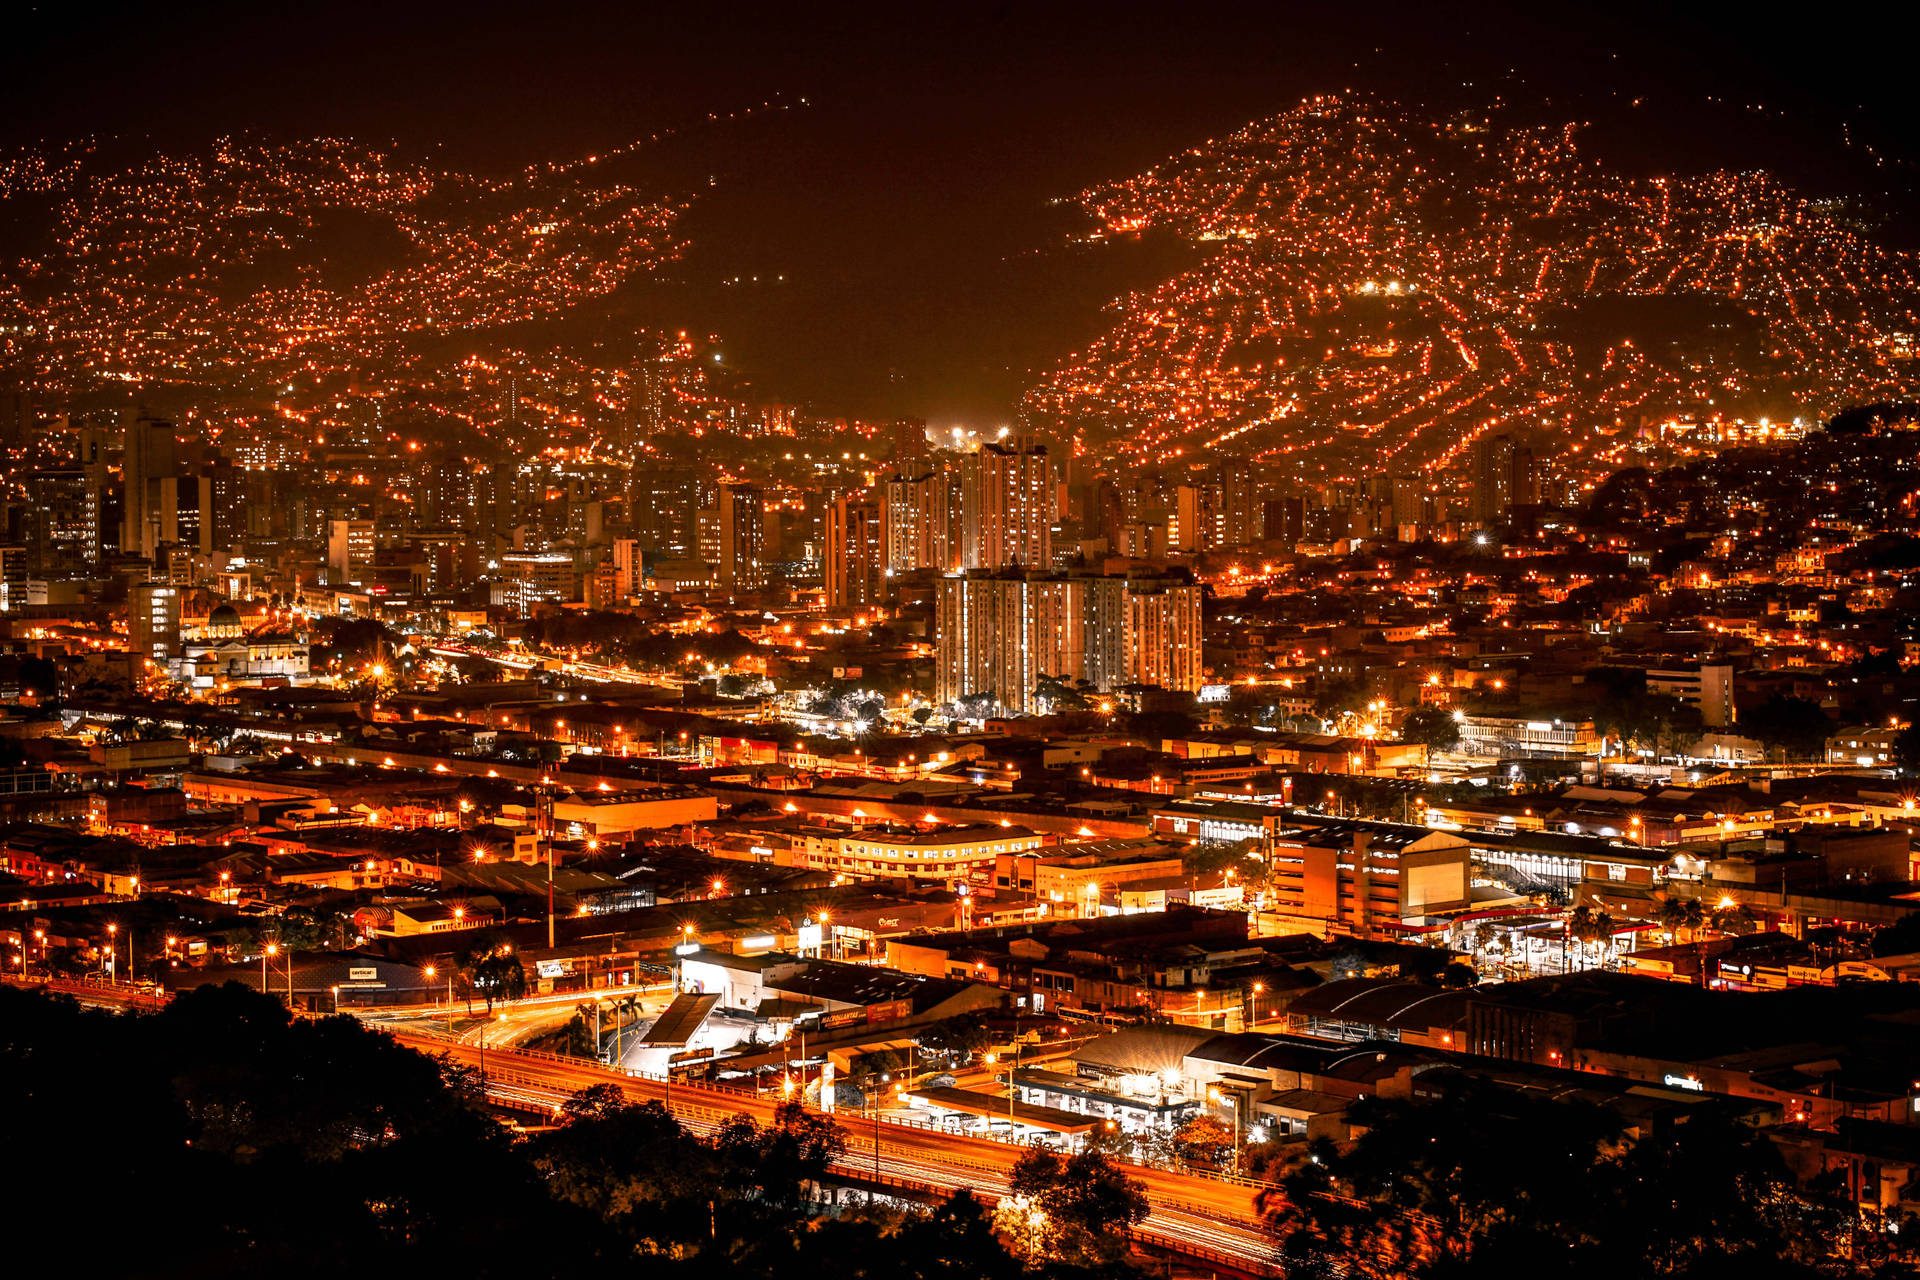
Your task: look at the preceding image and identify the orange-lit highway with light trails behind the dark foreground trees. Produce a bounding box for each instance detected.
[388,1027,1273,1274]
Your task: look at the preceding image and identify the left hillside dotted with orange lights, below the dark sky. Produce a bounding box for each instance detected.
[0,138,687,395]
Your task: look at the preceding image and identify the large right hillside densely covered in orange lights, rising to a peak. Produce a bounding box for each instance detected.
[1023,98,1920,480]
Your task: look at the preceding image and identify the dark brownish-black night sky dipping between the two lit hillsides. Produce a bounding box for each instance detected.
[0,0,1912,422]
